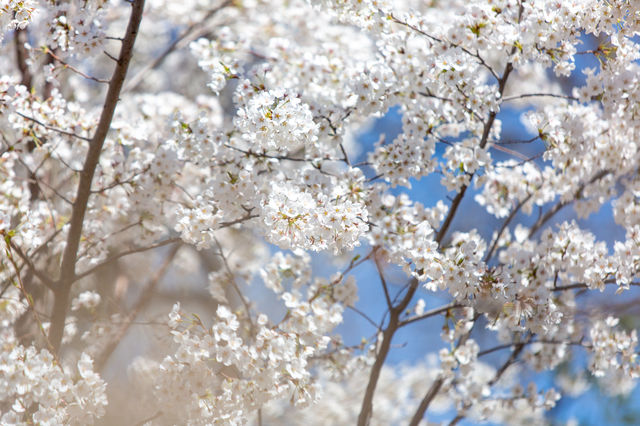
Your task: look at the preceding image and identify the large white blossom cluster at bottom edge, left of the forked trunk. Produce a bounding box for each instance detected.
[131,305,322,424]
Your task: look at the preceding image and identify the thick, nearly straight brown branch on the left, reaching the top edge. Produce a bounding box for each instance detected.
[49,0,144,352]
